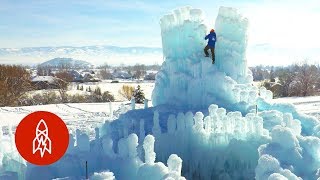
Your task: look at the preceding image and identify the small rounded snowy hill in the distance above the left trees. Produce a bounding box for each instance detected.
[39,58,93,68]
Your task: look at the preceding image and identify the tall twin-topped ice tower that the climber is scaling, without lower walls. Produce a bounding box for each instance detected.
[152,7,258,108]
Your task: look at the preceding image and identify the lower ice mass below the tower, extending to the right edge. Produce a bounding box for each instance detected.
[105,99,320,180]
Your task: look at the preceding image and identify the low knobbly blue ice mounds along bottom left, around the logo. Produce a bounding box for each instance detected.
[0,128,185,180]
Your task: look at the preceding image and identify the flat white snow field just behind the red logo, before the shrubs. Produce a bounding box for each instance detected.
[0,101,144,138]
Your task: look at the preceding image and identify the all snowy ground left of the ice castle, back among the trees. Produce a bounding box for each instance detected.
[0,81,154,138]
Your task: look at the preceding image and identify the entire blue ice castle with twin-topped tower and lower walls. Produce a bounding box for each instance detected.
[0,7,320,180]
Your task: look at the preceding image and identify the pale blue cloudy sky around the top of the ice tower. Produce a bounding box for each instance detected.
[0,0,320,64]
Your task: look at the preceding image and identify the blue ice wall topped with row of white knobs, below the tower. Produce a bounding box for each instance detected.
[105,104,271,179]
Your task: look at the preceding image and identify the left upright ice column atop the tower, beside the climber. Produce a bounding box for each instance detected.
[160,7,206,61]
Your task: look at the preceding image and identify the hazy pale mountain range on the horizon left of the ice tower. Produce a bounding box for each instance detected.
[0,46,163,65]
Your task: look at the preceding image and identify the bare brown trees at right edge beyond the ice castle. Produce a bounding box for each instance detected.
[251,62,320,97]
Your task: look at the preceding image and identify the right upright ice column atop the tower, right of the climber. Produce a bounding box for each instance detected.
[215,7,251,83]
